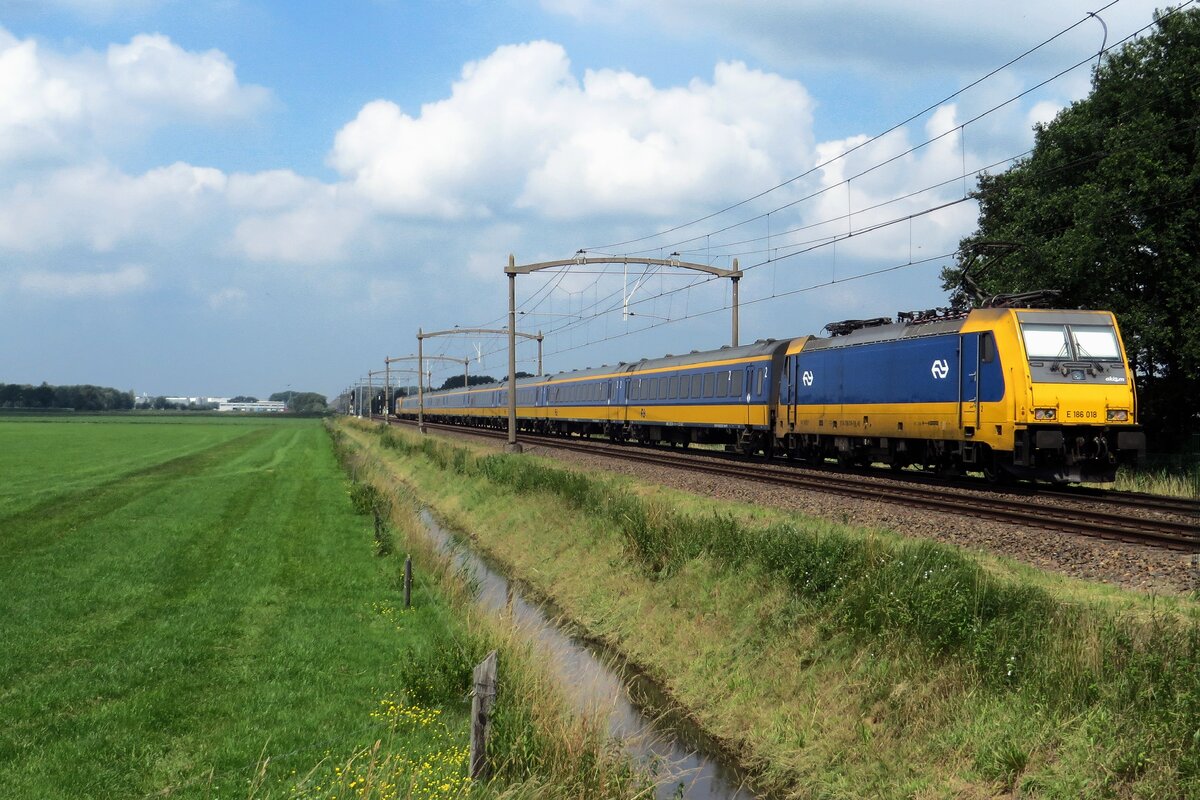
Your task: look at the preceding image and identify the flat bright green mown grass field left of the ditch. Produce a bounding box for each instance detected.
[0,420,462,798]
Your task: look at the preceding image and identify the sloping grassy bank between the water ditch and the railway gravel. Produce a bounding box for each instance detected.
[352,419,1200,798]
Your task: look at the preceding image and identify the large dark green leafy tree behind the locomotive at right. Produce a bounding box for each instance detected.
[942,10,1200,446]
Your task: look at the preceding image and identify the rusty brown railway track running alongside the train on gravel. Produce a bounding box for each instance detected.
[374,421,1200,552]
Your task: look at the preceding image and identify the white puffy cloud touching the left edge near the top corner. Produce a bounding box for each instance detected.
[0,28,270,167]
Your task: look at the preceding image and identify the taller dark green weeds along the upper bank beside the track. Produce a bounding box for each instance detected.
[364,424,1200,789]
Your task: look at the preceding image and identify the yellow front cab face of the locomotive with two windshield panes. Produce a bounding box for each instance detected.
[1013,309,1146,481]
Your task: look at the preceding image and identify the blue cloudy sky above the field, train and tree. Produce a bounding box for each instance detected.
[0,0,1156,397]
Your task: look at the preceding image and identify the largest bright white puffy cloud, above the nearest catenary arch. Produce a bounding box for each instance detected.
[330,42,812,218]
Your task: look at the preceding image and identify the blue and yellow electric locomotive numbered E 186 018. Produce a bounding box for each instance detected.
[775,308,1145,482]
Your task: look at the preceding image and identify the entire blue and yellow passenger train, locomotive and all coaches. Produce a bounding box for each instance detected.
[394,307,1146,482]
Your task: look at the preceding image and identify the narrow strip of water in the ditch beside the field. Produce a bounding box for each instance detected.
[420,511,758,800]
